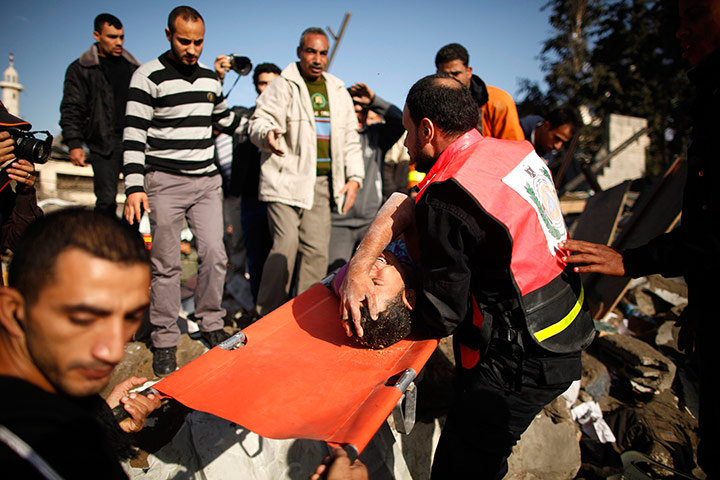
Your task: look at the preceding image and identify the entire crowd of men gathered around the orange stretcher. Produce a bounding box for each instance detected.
[0,0,720,479]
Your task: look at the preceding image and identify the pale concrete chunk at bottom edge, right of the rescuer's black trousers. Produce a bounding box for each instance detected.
[505,413,580,480]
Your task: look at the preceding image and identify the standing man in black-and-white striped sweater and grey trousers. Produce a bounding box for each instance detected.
[123,6,238,376]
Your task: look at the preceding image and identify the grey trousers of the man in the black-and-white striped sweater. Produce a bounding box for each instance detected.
[145,172,227,348]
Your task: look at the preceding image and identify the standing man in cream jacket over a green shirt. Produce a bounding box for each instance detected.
[250,28,364,315]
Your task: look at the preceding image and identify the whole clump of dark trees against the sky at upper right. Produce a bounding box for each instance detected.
[519,0,691,173]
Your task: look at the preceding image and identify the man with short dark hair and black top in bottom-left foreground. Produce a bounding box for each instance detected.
[0,209,159,478]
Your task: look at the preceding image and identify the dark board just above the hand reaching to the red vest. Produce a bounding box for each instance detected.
[570,180,631,245]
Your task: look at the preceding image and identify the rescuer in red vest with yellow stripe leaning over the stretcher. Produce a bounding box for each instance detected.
[341,75,594,479]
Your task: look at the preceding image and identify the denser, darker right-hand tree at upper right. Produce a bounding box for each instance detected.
[583,0,692,173]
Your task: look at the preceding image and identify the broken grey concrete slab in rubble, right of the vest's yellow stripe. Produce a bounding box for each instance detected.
[597,333,677,394]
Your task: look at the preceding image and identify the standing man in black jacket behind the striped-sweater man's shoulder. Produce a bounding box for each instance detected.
[60,13,140,216]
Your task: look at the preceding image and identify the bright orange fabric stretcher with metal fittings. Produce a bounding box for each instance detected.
[154,284,438,454]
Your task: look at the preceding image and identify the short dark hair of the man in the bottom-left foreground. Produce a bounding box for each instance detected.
[8,208,150,305]
